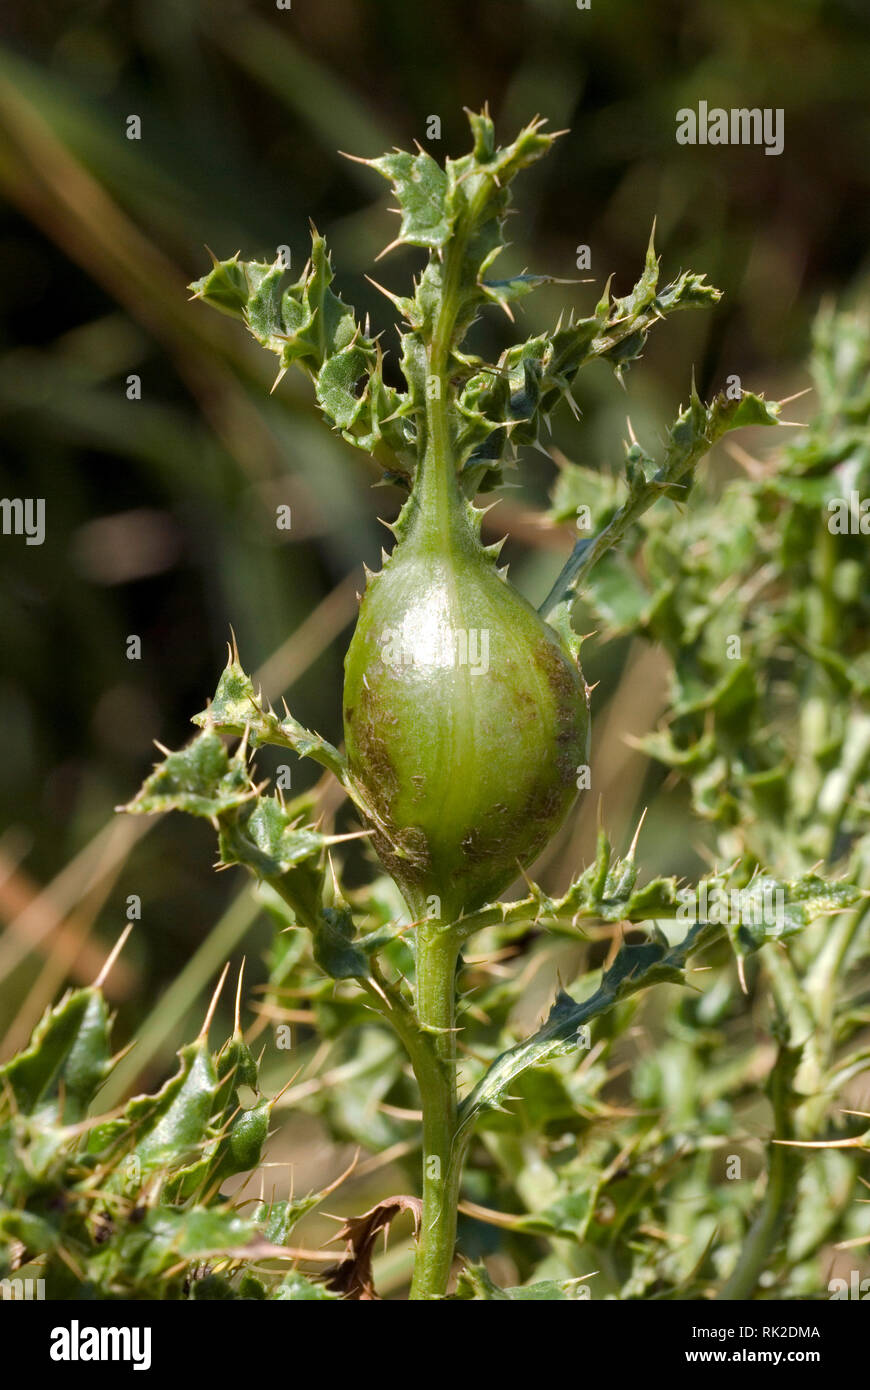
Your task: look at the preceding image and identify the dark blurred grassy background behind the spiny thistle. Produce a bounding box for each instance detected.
[0,0,870,1284]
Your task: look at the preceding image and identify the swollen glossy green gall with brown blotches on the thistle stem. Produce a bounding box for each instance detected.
[345,447,589,922]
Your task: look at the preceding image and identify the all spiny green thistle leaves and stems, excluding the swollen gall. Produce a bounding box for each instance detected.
[0,111,870,1301]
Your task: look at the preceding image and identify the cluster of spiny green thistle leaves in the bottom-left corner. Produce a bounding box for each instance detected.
[0,987,346,1300]
